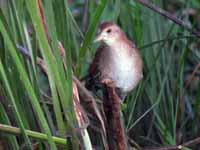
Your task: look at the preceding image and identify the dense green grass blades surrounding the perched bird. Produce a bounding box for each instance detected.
[0,0,200,150]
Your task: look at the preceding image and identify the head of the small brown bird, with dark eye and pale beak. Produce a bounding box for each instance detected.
[95,22,123,45]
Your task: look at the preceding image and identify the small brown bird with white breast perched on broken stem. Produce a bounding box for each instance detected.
[86,22,143,100]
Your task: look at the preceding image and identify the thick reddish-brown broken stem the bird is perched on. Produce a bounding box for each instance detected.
[103,85,126,150]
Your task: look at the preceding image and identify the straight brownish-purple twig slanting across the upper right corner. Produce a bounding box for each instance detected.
[136,0,200,37]
